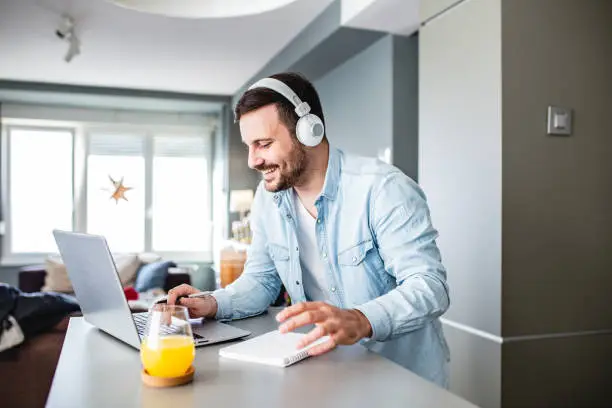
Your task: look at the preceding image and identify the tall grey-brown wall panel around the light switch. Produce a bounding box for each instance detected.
[503,0,612,336]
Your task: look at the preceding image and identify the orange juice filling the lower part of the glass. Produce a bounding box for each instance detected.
[140,336,195,378]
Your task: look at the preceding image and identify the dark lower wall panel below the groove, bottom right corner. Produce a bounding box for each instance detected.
[502,334,612,408]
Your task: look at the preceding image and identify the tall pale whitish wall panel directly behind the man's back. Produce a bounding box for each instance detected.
[419,0,502,407]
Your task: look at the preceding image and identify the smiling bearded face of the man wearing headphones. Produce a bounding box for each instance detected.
[240,105,306,192]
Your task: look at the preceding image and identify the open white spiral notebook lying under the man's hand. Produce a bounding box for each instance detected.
[219,330,329,367]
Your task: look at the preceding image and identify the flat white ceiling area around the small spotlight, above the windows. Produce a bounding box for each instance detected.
[0,0,332,95]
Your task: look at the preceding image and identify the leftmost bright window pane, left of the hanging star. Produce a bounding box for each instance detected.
[4,127,73,254]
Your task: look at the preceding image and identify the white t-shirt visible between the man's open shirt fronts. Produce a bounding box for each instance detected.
[292,190,328,301]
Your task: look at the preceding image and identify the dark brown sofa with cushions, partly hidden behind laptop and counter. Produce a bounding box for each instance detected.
[0,265,191,408]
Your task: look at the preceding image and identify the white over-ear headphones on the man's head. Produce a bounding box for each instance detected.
[249,78,325,147]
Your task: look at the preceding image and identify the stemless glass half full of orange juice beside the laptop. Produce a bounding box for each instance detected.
[140,304,195,378]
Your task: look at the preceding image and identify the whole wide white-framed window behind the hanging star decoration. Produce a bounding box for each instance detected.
[2,113,212,263]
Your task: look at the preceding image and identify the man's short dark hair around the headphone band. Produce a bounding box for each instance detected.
[234,72,325,136]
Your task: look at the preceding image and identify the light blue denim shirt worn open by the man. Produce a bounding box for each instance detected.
[214,147,449,387]
